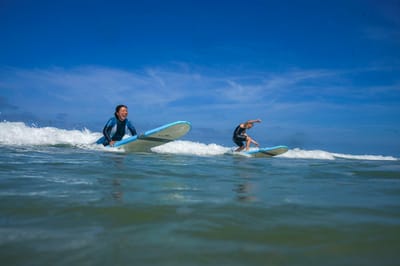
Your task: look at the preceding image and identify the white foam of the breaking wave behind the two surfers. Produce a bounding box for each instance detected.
[0,122,399,160]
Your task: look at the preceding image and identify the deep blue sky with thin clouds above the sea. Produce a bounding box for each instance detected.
[0,0,400,155]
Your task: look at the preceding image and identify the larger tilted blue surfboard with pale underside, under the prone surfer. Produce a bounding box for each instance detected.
[97,121,192,152]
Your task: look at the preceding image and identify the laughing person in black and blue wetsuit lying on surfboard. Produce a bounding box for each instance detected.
[99,104,137,146]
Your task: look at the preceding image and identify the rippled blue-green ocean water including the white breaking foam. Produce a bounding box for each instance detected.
[0,122,400,266]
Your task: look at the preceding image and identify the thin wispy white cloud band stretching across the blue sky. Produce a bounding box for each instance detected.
[0,65,400,130]
